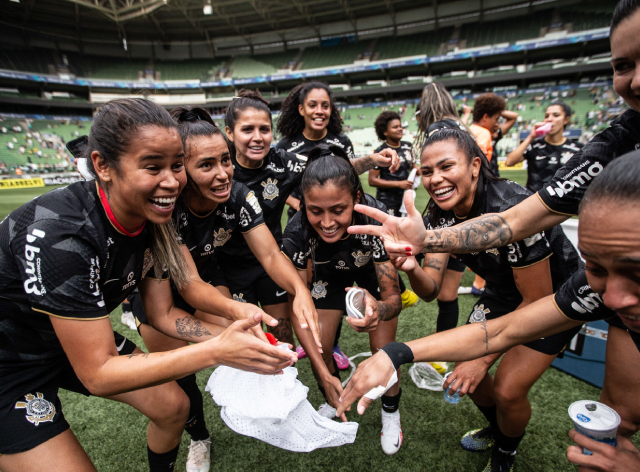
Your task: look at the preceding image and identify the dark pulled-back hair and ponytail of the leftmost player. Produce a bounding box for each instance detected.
[84,98,189,288]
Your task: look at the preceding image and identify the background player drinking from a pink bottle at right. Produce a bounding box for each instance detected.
[507,101,582,192]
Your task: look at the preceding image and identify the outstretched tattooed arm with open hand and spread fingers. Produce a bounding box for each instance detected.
[349,195,568,257]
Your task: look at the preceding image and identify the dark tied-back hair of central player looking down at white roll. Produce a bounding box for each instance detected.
[300,144,364,238]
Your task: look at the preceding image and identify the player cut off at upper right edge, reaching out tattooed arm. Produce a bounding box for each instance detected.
[350,0,640,450]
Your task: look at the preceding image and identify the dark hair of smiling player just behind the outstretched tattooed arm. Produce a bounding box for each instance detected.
[422,128,504,227]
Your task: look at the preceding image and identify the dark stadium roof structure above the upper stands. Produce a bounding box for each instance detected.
[0,0,598,51]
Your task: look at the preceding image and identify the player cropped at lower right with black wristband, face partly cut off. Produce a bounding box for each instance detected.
[338,151,640,471]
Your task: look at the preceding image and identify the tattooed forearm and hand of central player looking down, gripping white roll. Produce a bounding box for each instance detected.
[347,261,402,333]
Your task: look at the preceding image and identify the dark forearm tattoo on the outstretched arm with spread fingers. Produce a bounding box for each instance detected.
[423,213,513,254]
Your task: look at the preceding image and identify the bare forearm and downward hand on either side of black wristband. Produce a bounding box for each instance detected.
[338,295,582,414]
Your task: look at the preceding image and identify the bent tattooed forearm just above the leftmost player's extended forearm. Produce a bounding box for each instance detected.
[140,278,224,343]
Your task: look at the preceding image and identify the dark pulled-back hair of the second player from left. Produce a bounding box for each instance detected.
[169,105,229,198]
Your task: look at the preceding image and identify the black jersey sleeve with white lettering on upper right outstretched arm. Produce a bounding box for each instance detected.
[538,110,640,215]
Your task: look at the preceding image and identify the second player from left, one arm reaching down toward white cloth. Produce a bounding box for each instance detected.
[133,106,319,472]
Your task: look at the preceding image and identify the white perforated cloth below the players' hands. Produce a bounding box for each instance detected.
[205,348,358,452]
